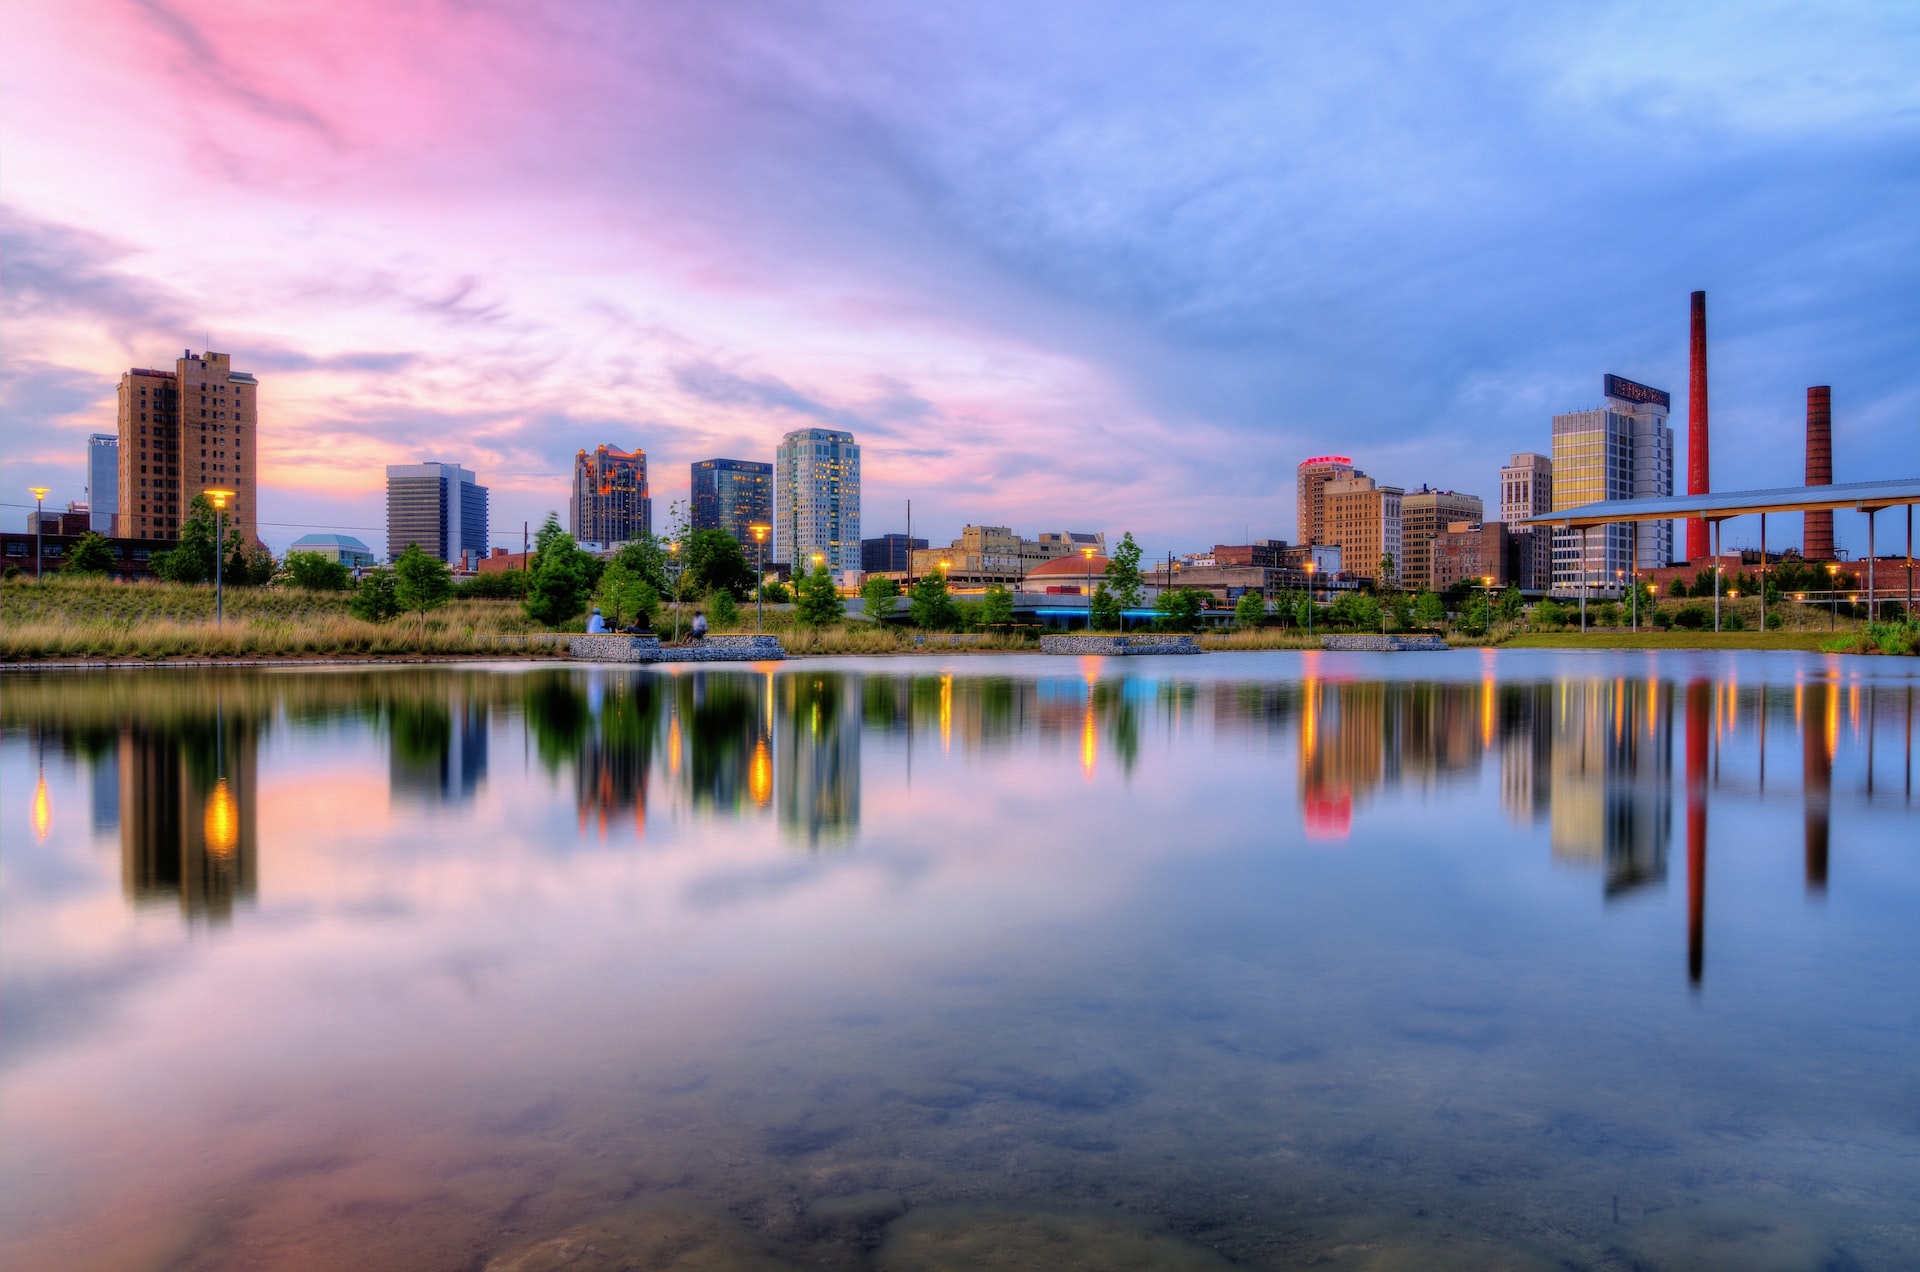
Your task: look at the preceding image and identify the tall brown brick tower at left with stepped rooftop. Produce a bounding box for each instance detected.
[117,350,259,544]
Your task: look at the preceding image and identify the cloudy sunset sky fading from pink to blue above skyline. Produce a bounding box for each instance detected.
[0,0,1920,555]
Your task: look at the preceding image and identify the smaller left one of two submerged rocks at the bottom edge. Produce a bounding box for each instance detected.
[486,1205,793,1272]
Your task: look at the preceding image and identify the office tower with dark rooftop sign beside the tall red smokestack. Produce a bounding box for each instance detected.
[1553,375,1674,596]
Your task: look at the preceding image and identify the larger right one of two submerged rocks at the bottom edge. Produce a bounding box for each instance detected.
[876,1207,1233,1272]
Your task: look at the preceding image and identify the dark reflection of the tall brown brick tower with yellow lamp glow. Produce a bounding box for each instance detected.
[119,705,259,922]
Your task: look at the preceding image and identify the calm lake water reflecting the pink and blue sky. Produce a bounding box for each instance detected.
[0,651,1920,1270]
